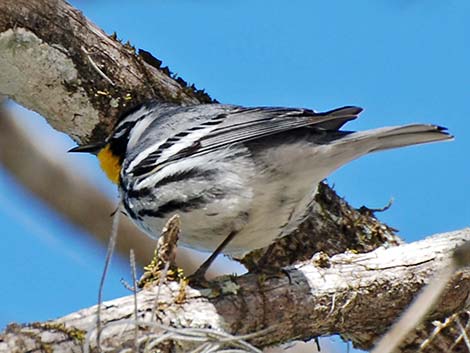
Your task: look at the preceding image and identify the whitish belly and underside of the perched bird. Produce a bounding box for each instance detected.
[123,143,354,257]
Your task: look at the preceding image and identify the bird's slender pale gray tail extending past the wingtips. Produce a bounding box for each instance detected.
[341,124,454,152]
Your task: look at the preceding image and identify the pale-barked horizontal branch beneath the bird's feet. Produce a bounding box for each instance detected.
[0,229,470,352]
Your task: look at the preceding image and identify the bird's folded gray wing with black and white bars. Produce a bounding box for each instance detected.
[132,106,362,176]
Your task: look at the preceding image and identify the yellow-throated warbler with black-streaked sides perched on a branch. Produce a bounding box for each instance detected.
[71,103,452,274]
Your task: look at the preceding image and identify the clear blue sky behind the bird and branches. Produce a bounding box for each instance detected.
[0,0,470,350]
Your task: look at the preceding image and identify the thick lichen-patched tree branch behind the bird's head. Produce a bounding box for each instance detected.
[0,0,211,141]
